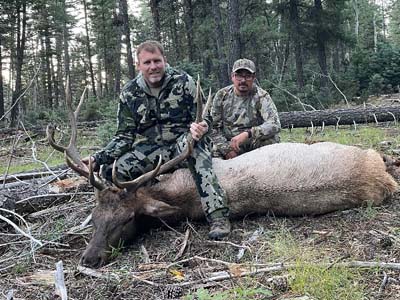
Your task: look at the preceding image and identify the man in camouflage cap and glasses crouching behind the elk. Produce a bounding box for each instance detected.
[211,58,281,159]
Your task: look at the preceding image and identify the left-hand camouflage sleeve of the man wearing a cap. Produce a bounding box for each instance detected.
[210,90,232,156]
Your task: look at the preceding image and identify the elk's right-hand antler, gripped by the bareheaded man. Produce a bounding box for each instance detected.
[112,76,211,190]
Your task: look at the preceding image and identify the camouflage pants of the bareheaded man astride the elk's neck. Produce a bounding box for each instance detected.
[101,135,229,220]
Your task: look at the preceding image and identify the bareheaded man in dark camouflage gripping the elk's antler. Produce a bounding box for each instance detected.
[86,41,230,239]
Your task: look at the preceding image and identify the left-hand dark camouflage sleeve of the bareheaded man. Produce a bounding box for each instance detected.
[94,94,136,165]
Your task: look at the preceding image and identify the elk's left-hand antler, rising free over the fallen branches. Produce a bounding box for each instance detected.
[46,77,105,189]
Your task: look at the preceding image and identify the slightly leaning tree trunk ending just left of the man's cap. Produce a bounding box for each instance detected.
[212,0,229,86]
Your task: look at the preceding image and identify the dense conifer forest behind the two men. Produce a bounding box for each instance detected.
[0,0,400,128]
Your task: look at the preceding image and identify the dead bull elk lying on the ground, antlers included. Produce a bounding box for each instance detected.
[48,80,397,267]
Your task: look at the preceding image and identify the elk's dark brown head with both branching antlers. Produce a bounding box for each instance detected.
[47,79,211,268]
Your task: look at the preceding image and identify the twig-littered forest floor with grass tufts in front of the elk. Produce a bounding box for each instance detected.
[0,118,400,300]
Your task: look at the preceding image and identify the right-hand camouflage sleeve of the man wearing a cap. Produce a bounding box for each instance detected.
[252,93,281,139]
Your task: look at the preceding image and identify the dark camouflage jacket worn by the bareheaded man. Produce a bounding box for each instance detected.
[94,67,200,165]
